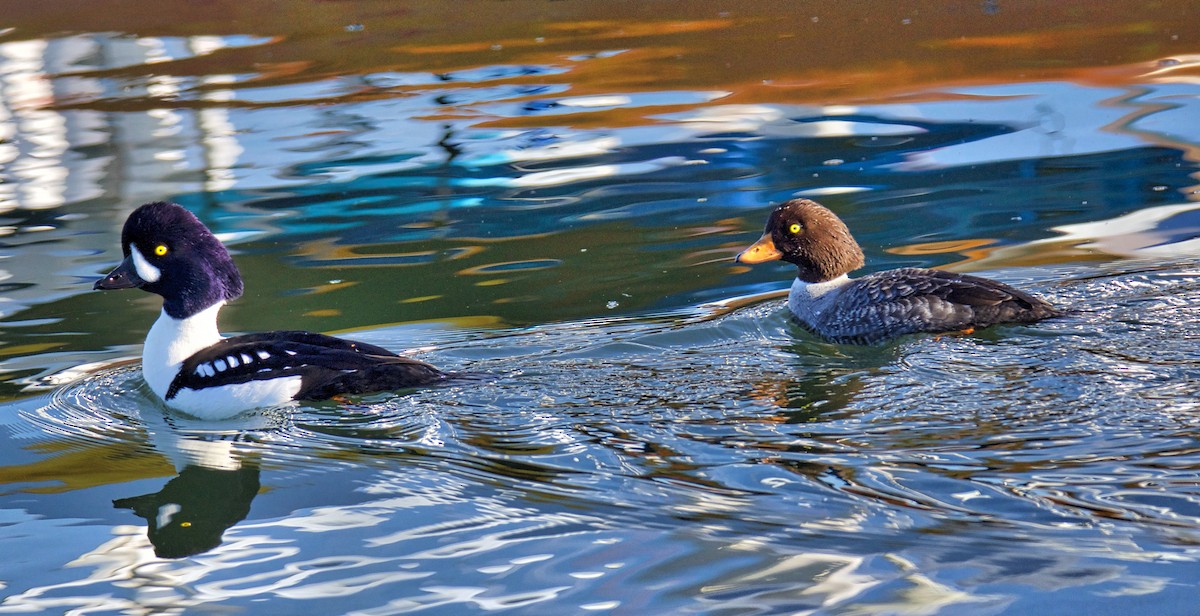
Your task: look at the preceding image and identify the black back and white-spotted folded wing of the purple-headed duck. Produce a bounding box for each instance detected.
[166,331,442,400]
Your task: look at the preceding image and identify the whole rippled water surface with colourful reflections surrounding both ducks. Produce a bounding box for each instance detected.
[0,2,1200,615]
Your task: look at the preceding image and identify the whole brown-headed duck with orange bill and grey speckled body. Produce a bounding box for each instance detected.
[737,199,1062,345]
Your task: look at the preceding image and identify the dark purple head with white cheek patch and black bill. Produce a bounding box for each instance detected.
[94,202,242,318]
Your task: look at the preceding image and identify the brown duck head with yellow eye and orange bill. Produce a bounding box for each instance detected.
[737,199,863,282]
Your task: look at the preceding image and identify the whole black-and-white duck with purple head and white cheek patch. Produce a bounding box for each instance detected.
[94,202,446,419]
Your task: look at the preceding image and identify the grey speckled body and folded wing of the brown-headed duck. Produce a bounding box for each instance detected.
[810,268,1060,343]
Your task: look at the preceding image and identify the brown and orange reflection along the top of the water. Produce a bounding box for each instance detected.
[9,0,1200,115]
